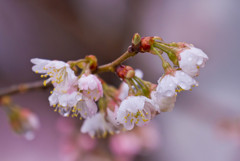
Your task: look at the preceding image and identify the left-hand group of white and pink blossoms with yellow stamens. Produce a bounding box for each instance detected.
[31,58,103,118]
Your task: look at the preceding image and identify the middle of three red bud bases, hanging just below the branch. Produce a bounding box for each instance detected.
[116,65,135,79]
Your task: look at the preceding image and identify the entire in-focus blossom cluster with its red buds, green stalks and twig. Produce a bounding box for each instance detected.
[31,34,208,137]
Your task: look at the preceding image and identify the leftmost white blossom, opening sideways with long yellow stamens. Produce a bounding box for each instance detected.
[31,58,76,87]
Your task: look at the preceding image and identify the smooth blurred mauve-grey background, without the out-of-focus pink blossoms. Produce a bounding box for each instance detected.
[0,0,240,161]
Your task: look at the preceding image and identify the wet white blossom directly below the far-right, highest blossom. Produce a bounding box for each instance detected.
[156,70,198,97]
